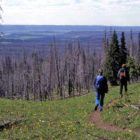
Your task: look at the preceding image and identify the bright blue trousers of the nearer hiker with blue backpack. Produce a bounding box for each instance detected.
[95,91,105,109]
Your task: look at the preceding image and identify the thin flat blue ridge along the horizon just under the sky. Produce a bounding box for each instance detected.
[0,25,140,31]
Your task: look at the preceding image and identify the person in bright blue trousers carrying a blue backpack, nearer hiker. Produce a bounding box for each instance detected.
[94,69,108,111]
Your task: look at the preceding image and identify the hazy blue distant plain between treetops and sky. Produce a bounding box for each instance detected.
[0,25,140,54]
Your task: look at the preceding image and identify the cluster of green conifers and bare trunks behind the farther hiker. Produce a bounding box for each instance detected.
[103,31,140,85]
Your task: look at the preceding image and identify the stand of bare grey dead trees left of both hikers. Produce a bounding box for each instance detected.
[0,42,98,101]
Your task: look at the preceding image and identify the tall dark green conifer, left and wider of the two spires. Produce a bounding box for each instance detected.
[104,31,120,85]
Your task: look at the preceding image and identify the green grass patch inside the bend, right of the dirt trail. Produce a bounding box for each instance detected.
[102,84,140,130]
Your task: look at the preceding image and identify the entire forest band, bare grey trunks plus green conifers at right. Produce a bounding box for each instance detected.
[0,31,140,101]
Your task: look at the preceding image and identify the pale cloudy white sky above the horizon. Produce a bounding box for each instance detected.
[1,0,140,26]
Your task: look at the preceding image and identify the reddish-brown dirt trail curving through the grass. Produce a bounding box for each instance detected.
[90,98,140,136]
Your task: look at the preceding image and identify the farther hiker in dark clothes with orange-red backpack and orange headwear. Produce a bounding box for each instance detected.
[118,64,130,97]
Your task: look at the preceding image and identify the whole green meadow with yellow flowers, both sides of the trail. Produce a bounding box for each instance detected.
[0,84,140,140]
